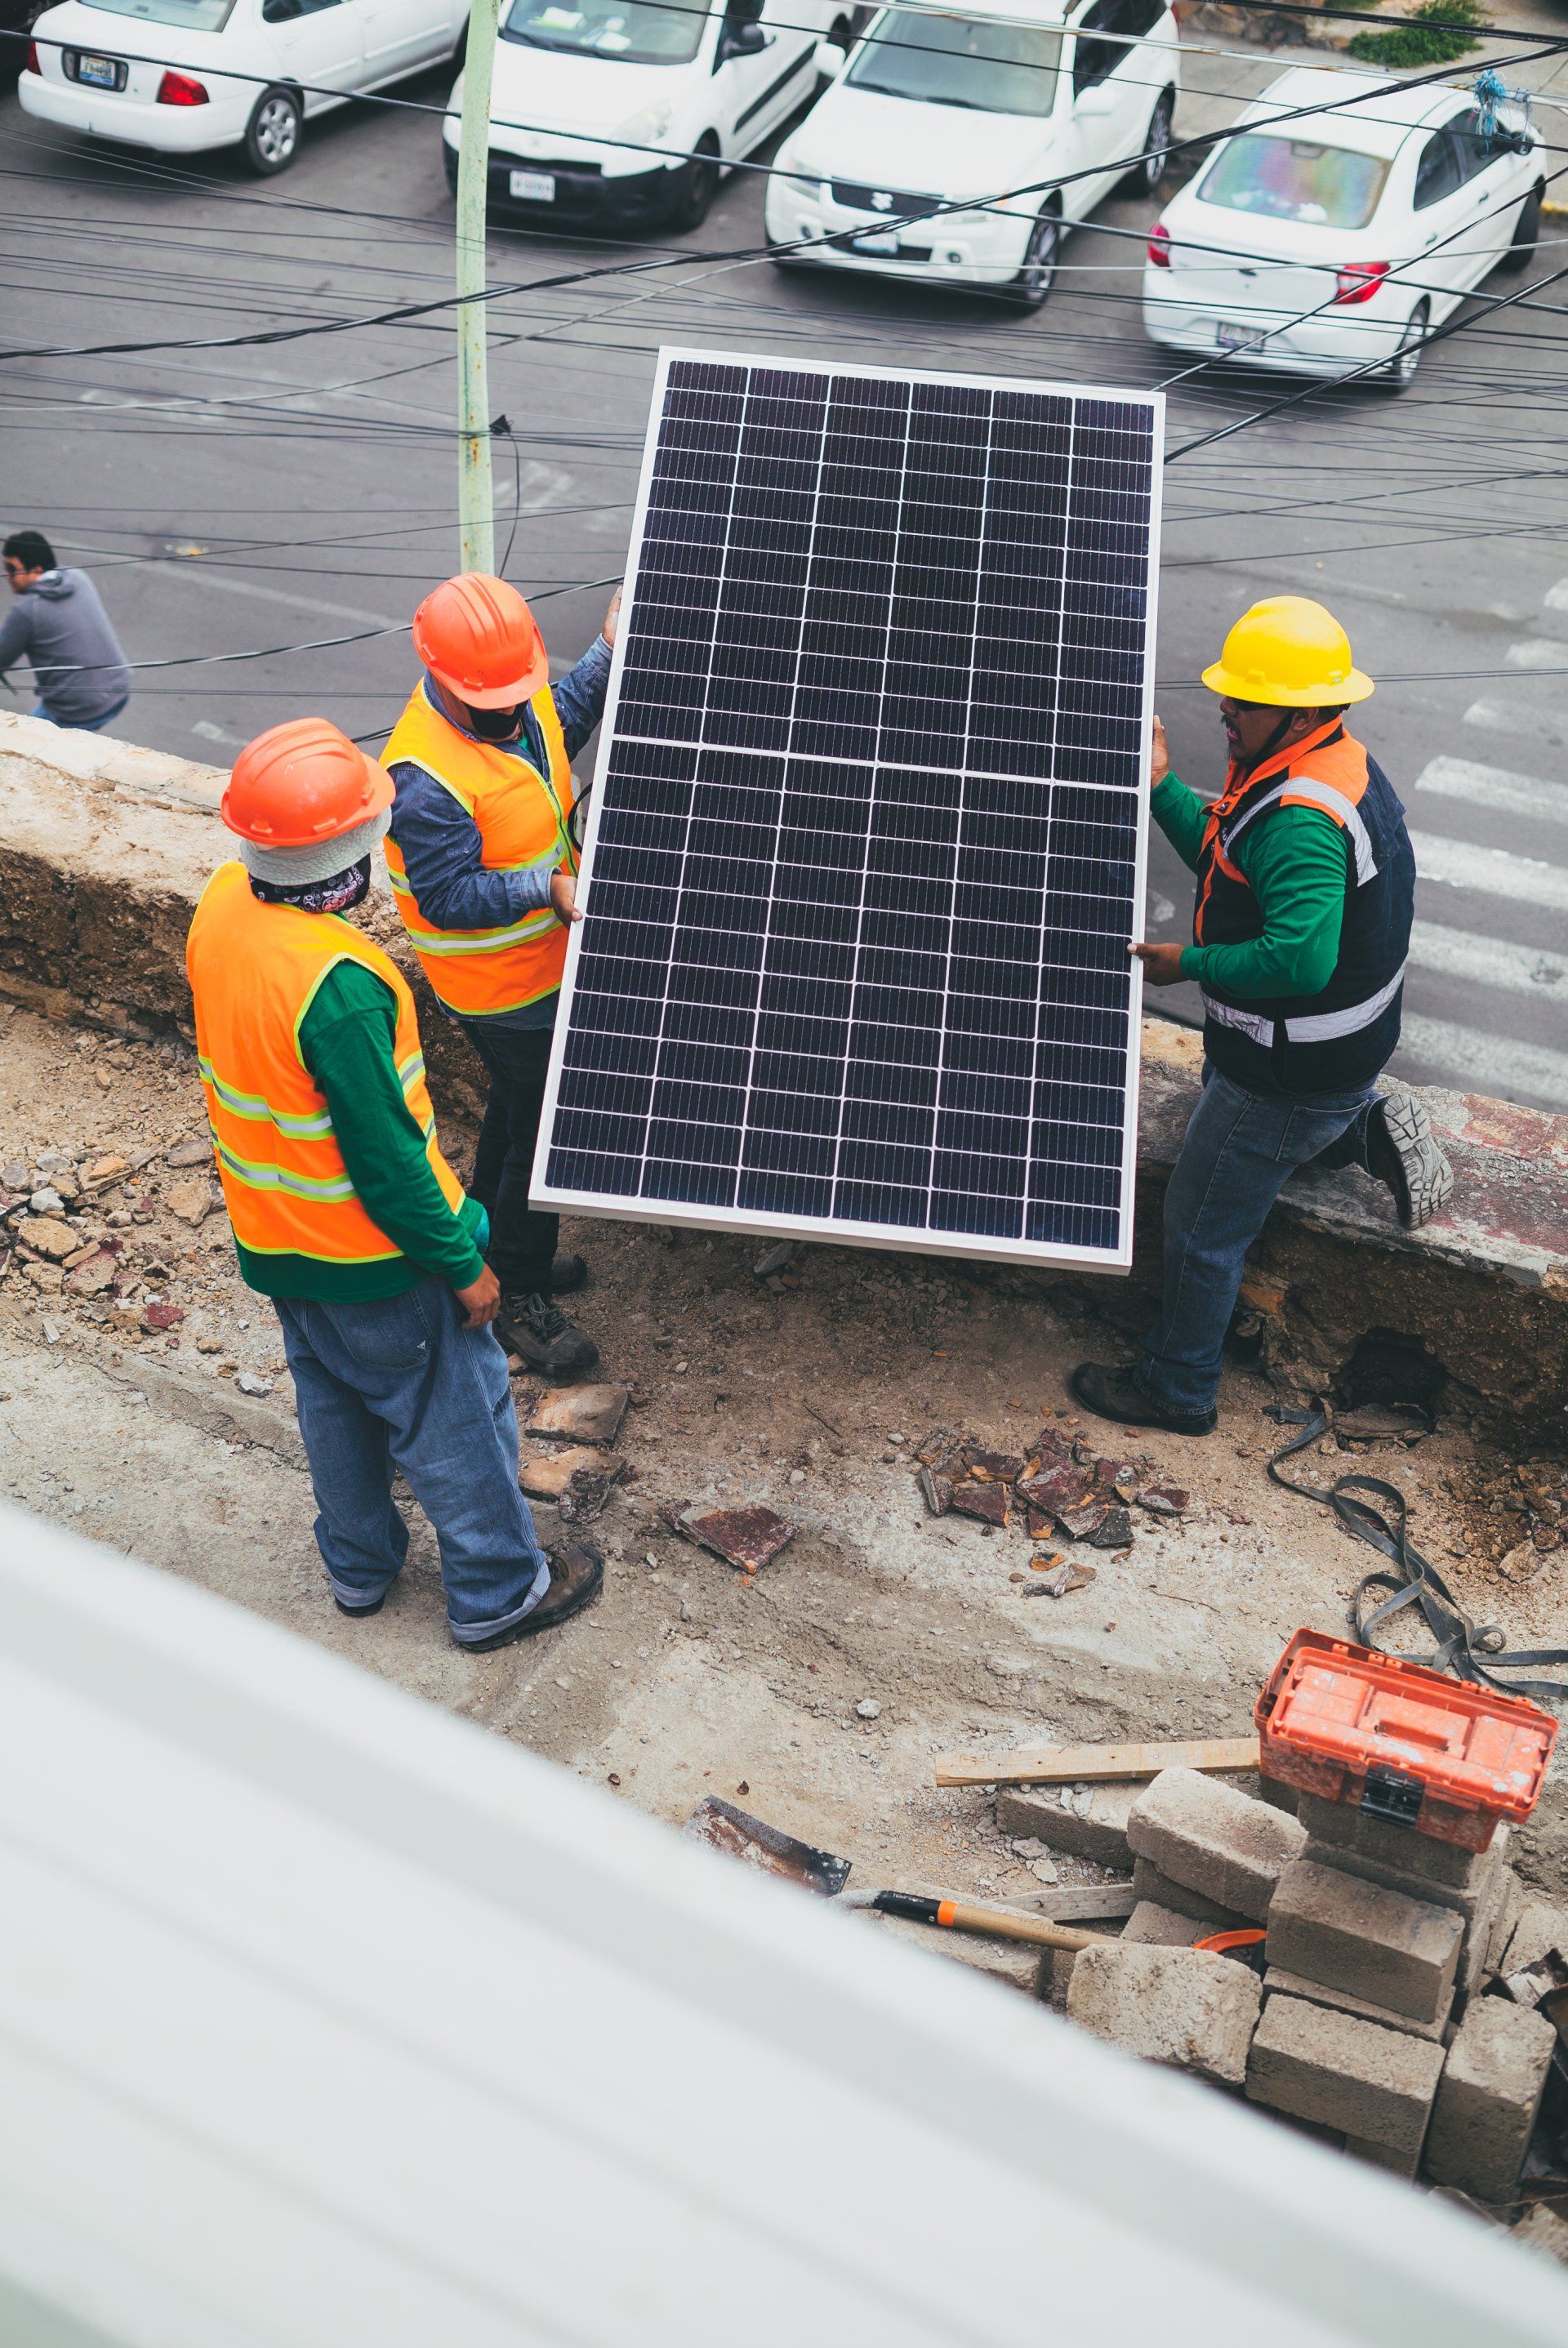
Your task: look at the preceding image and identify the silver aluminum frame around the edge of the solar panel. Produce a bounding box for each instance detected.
[528,345,1165,1272]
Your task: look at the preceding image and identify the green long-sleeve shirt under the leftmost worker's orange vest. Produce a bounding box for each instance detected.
[234,963,488,1303]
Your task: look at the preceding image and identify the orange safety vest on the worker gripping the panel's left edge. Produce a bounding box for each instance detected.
[381,681,577,1019]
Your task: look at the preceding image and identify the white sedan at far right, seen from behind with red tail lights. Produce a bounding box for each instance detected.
[1143,66,1544,392]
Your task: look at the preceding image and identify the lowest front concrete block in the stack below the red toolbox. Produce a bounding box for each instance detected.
[1221,1991,1444,2158]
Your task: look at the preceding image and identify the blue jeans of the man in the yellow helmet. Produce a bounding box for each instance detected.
[1134,1062,1378,1411]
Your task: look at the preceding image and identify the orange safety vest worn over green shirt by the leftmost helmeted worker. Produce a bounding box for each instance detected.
[185,864,462,1263]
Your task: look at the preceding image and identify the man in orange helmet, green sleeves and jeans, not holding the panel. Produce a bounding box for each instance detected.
[185,719,604,1653]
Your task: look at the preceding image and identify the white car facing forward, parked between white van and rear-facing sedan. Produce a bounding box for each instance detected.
[768,0,1181,308]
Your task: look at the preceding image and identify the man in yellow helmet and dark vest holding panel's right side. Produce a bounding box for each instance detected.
[1071,596,1453,1435]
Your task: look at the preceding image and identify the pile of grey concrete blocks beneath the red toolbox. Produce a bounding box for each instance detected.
[1027,1768,1568,2219]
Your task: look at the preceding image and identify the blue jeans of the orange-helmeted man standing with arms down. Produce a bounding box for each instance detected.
[272,1280,550,1646]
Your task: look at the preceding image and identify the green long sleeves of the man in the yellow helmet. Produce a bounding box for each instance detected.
[1150,775,1348,998]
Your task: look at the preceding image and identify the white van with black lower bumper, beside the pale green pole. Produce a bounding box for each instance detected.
[443,0,864,228]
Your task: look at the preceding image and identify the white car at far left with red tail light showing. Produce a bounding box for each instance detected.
[16,0,467,172]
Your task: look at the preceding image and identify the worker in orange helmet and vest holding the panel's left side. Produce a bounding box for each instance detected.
[383,571,620,1383]
